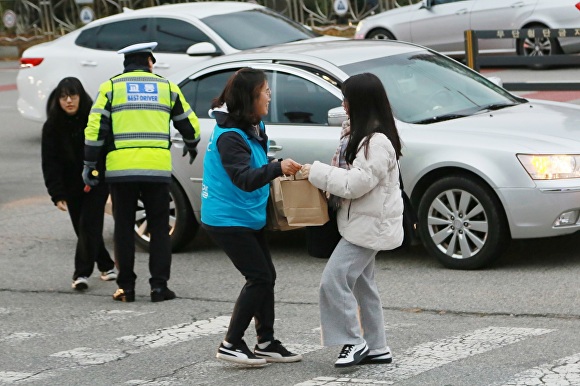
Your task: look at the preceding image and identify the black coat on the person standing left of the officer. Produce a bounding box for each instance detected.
[41,114,105,204]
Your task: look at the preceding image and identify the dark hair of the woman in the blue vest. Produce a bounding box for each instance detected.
[211,67,268,128]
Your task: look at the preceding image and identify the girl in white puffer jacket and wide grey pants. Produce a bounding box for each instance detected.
[302,73,403,367]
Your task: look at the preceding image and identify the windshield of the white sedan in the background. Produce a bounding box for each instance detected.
[202,10,318,50]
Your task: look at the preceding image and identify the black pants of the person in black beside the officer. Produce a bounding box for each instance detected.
[66,183,115,280]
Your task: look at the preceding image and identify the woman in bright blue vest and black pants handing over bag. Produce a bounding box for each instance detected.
[201,68,302,366]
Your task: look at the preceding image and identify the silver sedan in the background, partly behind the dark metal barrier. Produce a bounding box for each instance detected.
[355,0,580,57]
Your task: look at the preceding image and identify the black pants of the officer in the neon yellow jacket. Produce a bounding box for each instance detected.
[110,182,171,291]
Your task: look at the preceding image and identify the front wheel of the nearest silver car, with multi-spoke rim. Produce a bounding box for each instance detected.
[418,176,509,270]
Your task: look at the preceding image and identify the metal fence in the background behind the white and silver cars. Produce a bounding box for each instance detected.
[0,0,420,41]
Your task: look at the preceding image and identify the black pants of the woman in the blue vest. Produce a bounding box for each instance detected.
[206,229,276,344]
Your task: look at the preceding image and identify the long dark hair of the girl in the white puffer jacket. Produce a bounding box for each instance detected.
[342,73,402,165]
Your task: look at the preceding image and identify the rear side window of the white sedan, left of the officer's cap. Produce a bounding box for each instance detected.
[75,18,151,51]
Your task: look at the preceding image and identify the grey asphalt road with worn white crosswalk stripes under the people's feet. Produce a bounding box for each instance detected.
[0,63,580,386]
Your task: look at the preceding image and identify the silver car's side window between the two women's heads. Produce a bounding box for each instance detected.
[269,72,341,125]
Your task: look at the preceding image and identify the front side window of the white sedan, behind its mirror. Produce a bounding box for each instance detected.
[155,18,211,54]
